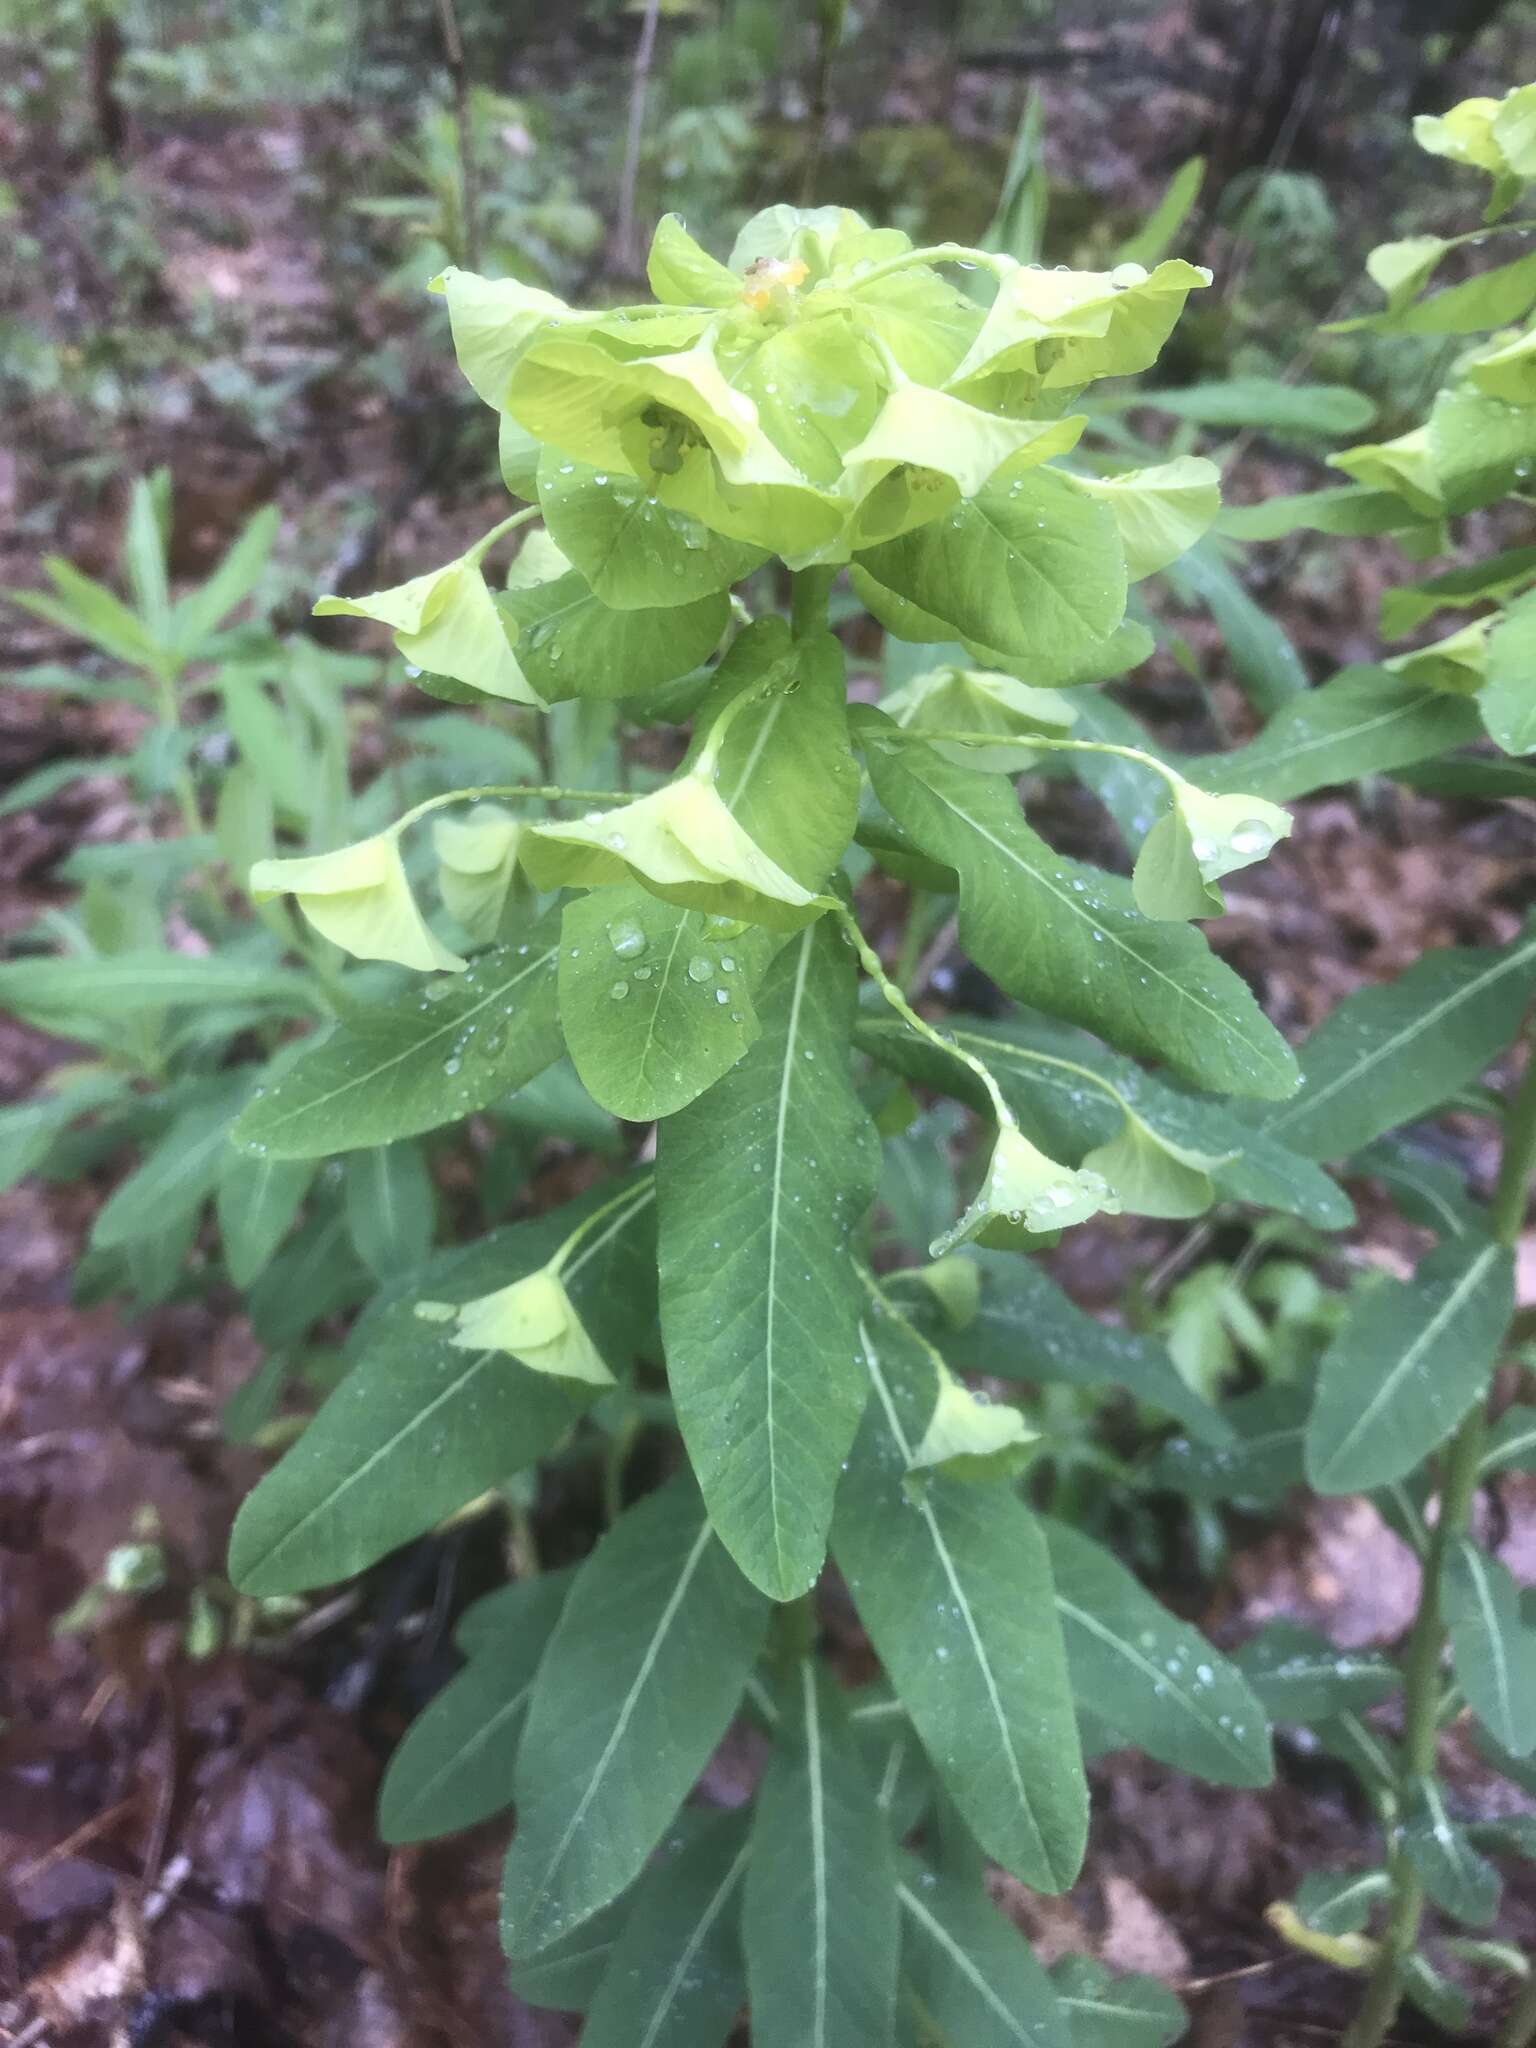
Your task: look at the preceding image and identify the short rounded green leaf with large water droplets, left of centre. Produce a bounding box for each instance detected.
[559,883,780,1122]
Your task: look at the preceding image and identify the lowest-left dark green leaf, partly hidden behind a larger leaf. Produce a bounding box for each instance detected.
[379,1571,569,1843]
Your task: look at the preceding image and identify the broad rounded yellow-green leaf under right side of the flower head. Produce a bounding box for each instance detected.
[858,465,1126,682]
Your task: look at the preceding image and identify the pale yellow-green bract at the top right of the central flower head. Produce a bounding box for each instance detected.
[950,258,1210,391]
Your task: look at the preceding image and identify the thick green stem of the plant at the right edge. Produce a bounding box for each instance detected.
[1343,1044,1536,2048]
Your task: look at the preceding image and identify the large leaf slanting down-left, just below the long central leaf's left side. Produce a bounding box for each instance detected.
[502,1475,768,1958]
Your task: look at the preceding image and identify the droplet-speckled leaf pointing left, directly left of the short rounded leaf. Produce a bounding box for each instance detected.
[233,909,561,1159]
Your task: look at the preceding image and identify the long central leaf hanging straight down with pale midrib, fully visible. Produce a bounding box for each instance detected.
[657,924,879,1599]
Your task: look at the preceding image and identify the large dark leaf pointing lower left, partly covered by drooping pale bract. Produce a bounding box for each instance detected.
[229,1184,653,1595]
